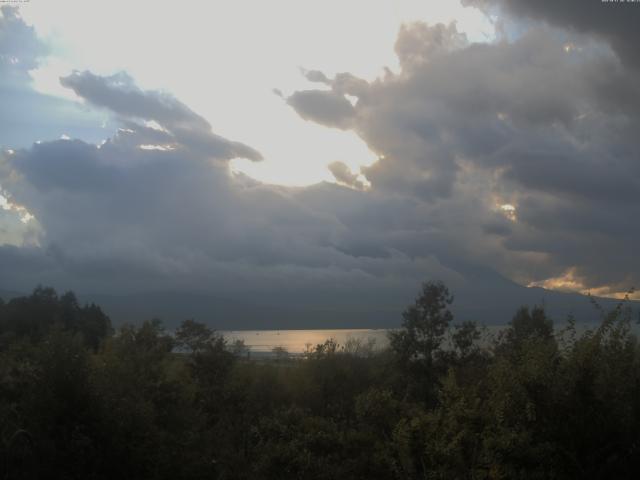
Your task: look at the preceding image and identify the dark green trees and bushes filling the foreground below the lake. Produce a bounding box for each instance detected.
[0,283,640,480]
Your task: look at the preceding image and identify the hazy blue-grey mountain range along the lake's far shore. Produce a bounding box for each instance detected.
[0,272,640,330]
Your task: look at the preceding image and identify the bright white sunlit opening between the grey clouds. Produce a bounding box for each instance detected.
[21,0,493,185]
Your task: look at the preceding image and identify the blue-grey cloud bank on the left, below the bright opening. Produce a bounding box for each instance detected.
[0,68,470,311]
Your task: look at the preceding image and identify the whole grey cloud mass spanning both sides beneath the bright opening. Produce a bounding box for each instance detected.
[0,3,640,324]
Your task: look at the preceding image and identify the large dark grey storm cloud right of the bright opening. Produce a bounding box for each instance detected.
[288,18,640,294]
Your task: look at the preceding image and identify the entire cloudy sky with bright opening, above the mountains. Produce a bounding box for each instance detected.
[0,0,640,322]
